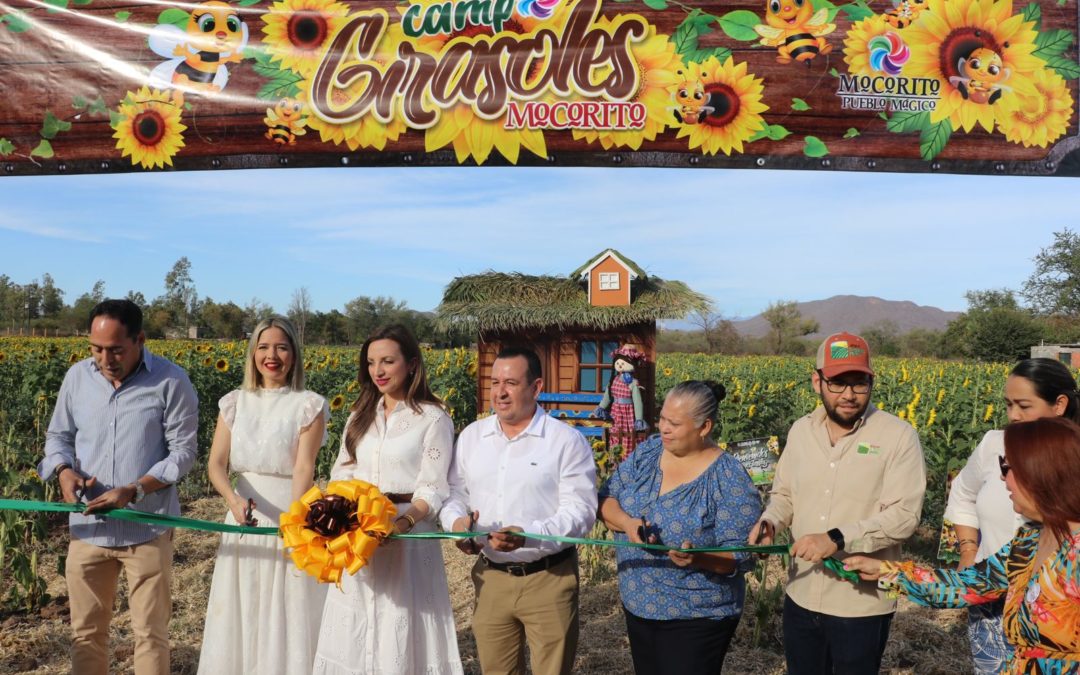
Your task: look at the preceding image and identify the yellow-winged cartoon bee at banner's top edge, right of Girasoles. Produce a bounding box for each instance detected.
[754,0,836,65]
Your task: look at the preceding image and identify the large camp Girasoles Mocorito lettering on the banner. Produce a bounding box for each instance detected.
[308,0,648,129]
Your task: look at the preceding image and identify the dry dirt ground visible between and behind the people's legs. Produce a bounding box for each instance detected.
[0,498,971,675]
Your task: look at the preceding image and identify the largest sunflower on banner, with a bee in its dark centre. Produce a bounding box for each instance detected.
[904,0,1042,132]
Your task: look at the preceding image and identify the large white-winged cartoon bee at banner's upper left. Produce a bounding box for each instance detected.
[149,0,247,92]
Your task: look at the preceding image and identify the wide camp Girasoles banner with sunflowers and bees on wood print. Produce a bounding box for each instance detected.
[0,0,1080,175]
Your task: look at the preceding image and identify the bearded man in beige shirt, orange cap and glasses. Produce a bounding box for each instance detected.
[750,333,927,675]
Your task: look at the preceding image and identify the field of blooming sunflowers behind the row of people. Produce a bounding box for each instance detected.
[0,338,1009,607]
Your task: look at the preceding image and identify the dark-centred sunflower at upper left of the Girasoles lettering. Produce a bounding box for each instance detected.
[262,0,349,77]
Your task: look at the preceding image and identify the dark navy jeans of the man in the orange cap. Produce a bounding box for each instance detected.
[784,597,892,675]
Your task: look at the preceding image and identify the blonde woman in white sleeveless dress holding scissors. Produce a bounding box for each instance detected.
[199,316,329,675]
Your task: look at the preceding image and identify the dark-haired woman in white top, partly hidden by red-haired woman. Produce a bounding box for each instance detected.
[945,359,1080,675]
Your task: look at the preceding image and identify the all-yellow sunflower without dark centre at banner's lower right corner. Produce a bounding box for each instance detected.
[998,68,1072,148]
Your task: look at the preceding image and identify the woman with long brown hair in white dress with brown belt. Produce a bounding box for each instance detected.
[314,325,462,675]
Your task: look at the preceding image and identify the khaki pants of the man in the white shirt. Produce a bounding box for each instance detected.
[472,555,578,675]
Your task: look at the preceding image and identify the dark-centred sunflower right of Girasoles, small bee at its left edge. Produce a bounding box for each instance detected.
[677,56,769,154]
